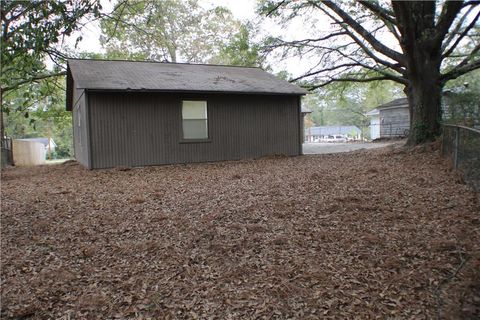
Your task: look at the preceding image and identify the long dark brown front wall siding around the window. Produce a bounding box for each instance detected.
[88,92,301,168]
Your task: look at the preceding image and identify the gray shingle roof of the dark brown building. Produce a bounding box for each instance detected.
[68,60,307,95]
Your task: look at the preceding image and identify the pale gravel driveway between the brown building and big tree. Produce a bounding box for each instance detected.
[303,140,399,154]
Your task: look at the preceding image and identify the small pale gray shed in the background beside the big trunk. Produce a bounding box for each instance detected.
[365,98,410,140]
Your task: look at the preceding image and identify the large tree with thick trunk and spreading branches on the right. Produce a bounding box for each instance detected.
[261,0,480,144]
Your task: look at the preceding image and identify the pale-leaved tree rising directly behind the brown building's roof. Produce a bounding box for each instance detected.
[100,0,238,62]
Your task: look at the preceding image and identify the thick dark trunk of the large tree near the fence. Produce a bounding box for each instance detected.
[392,1,450,145]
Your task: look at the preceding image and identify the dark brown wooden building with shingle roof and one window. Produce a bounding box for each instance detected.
[66,59,307,169]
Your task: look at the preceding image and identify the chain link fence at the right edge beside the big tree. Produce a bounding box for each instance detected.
[442,124,480,192]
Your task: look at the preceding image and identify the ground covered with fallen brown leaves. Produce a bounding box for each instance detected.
[0,147,480,319]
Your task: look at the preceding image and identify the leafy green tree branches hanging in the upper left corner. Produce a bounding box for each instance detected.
[0,0,101,137]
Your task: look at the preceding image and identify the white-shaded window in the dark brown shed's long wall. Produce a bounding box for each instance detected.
[182,101,208,139]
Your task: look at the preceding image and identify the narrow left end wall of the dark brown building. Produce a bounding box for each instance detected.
[72,89,89,167]
